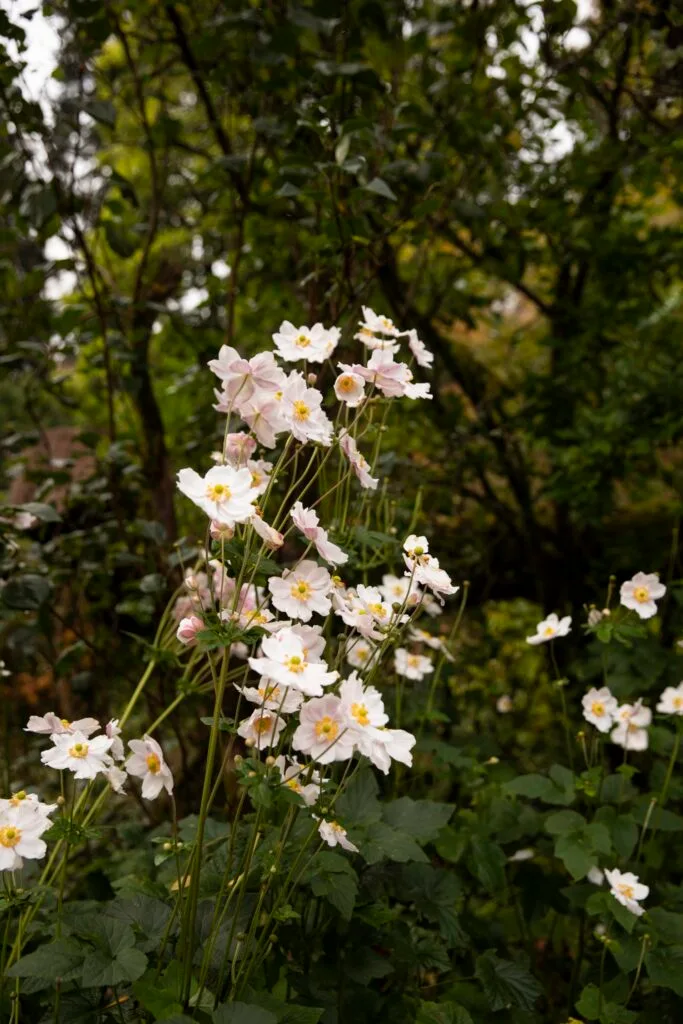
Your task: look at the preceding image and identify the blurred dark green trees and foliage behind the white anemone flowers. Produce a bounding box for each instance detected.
[0,0,683,778]
